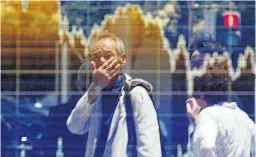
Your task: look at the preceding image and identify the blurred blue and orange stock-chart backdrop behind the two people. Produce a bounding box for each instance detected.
[1,0,256,157]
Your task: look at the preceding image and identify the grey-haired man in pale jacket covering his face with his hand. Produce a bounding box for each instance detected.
[67,33,161,157]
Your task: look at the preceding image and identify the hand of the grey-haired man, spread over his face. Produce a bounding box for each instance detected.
[91,57,121,88]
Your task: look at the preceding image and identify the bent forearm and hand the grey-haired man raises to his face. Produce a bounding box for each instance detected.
[67,58,120,135]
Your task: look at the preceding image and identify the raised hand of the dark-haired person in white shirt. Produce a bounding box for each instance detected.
[186,98,201,124]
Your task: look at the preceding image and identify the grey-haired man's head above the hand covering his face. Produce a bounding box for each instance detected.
[91,38,125,68]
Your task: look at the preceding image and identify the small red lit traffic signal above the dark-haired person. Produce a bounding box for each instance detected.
[222,11,241,28]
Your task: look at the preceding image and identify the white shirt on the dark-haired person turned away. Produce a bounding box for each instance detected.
[193,102,256,157]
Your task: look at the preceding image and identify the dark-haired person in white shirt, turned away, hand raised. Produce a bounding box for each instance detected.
[186,40,256,157]
